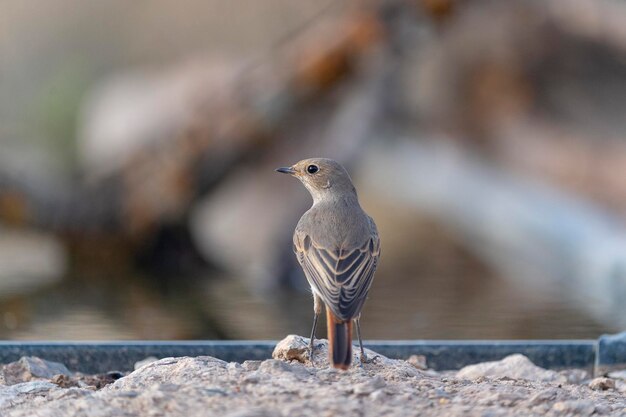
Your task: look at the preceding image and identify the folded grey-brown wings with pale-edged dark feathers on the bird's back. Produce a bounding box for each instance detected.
[294,227,380,320]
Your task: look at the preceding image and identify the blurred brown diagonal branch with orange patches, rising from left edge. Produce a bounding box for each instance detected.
[0,0,390,244]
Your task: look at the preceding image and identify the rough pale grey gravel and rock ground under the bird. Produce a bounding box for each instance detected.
[0,336,626,417]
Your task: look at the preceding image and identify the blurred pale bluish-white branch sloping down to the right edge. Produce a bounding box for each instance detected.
[367,139,626,328]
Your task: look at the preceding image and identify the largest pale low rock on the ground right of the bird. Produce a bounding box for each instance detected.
[456,354,567,382]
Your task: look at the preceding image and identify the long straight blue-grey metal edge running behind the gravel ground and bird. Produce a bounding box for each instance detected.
[0,340,599,373]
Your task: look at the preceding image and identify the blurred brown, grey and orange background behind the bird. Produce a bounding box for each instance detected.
[0,0,626,340]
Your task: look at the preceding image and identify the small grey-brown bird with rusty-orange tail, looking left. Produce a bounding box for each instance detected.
[276,158,380,370]
